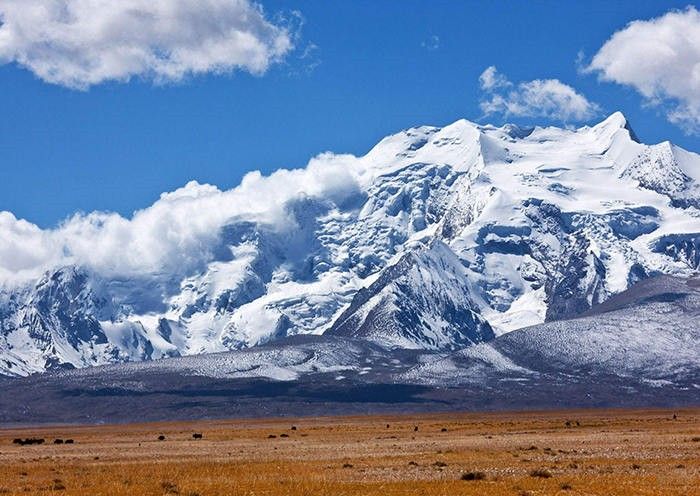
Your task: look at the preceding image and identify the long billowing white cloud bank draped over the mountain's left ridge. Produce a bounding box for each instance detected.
[0,153,361,285]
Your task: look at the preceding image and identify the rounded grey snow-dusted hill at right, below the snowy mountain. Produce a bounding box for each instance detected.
[403,276,700,388]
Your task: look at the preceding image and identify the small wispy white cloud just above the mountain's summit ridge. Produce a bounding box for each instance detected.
[479,66,600,122]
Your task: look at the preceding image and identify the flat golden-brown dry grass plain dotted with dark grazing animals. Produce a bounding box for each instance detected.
[0,409,700,496]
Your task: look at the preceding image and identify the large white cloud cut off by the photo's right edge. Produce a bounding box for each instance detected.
[586,7,700,133]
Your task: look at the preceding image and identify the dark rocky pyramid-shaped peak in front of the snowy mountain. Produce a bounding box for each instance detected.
[329,239,495,350]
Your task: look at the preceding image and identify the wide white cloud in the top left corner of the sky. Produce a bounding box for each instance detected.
[0,0,294,89]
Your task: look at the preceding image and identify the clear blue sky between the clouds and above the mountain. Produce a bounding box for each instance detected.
[0,0,700,227]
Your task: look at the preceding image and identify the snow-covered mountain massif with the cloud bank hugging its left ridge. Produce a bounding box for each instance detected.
[0,113,700,375]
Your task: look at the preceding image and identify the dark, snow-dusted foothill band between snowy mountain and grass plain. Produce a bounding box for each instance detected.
[0,276,700,424]
